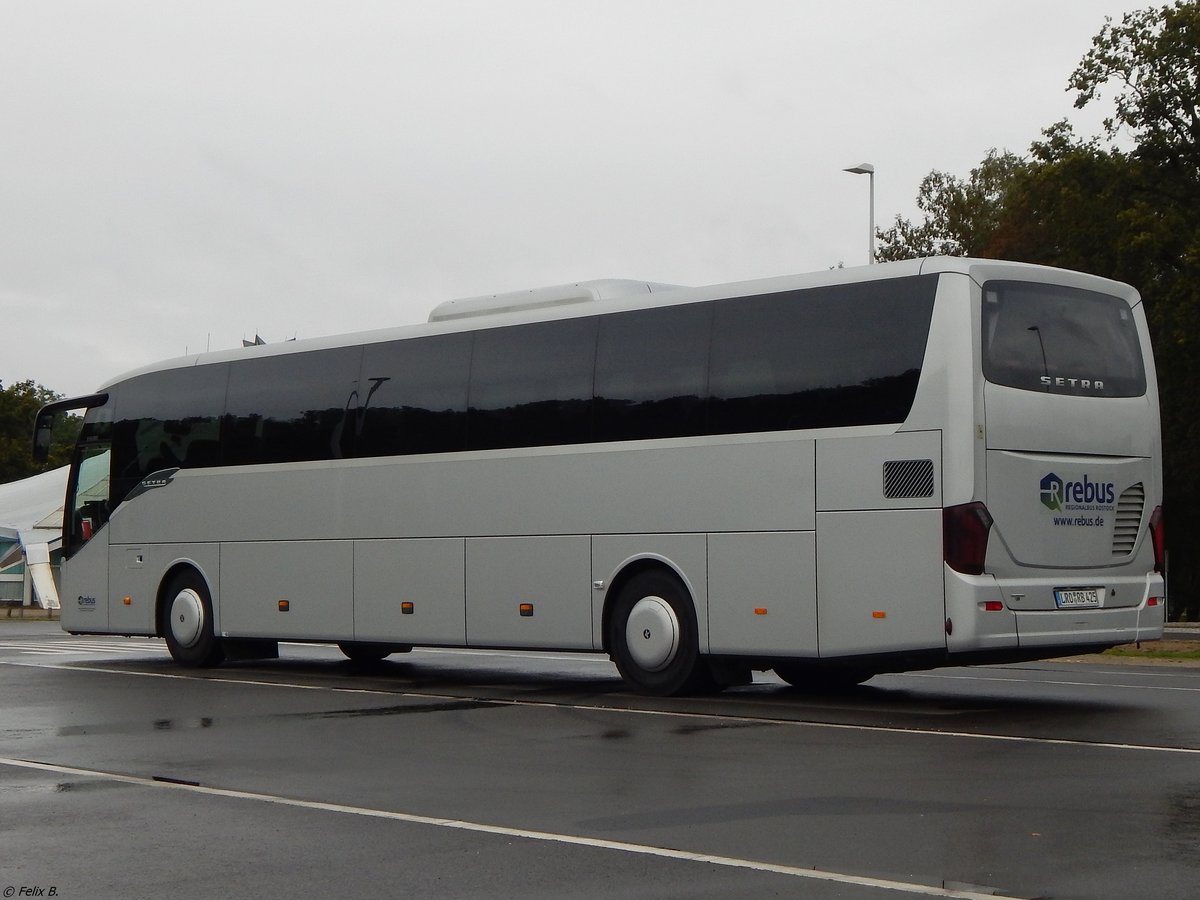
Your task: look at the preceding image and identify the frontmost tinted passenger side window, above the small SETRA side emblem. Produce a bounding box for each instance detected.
[110,365,229,506]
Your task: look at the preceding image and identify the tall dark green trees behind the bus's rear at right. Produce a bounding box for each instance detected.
[877,0,1200,620]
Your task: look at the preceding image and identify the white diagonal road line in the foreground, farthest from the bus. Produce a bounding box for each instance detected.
[0,757,1015,900]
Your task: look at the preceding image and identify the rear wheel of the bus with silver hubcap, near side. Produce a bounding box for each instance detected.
[608,570,715,697]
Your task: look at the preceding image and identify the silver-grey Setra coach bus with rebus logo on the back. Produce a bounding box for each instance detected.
[35,258,1165,695]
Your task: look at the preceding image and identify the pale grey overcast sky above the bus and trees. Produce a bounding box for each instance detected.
[0,0,1148,395]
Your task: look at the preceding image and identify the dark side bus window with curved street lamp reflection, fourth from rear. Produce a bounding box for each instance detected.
[358,335,470,456]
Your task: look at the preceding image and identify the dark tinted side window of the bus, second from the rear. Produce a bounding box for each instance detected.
[595,304,713,440]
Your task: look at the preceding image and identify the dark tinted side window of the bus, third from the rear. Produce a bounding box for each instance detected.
[467,318,596,450]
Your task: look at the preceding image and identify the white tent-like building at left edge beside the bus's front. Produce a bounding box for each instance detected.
[0,467,67,610]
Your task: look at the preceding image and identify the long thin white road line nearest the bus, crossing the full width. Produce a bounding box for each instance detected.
[7,660,1200,756]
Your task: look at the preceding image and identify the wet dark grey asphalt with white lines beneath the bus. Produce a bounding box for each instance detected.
[0,623,1200,900]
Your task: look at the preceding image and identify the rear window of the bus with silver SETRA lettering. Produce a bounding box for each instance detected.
[983,281,1146,397]
